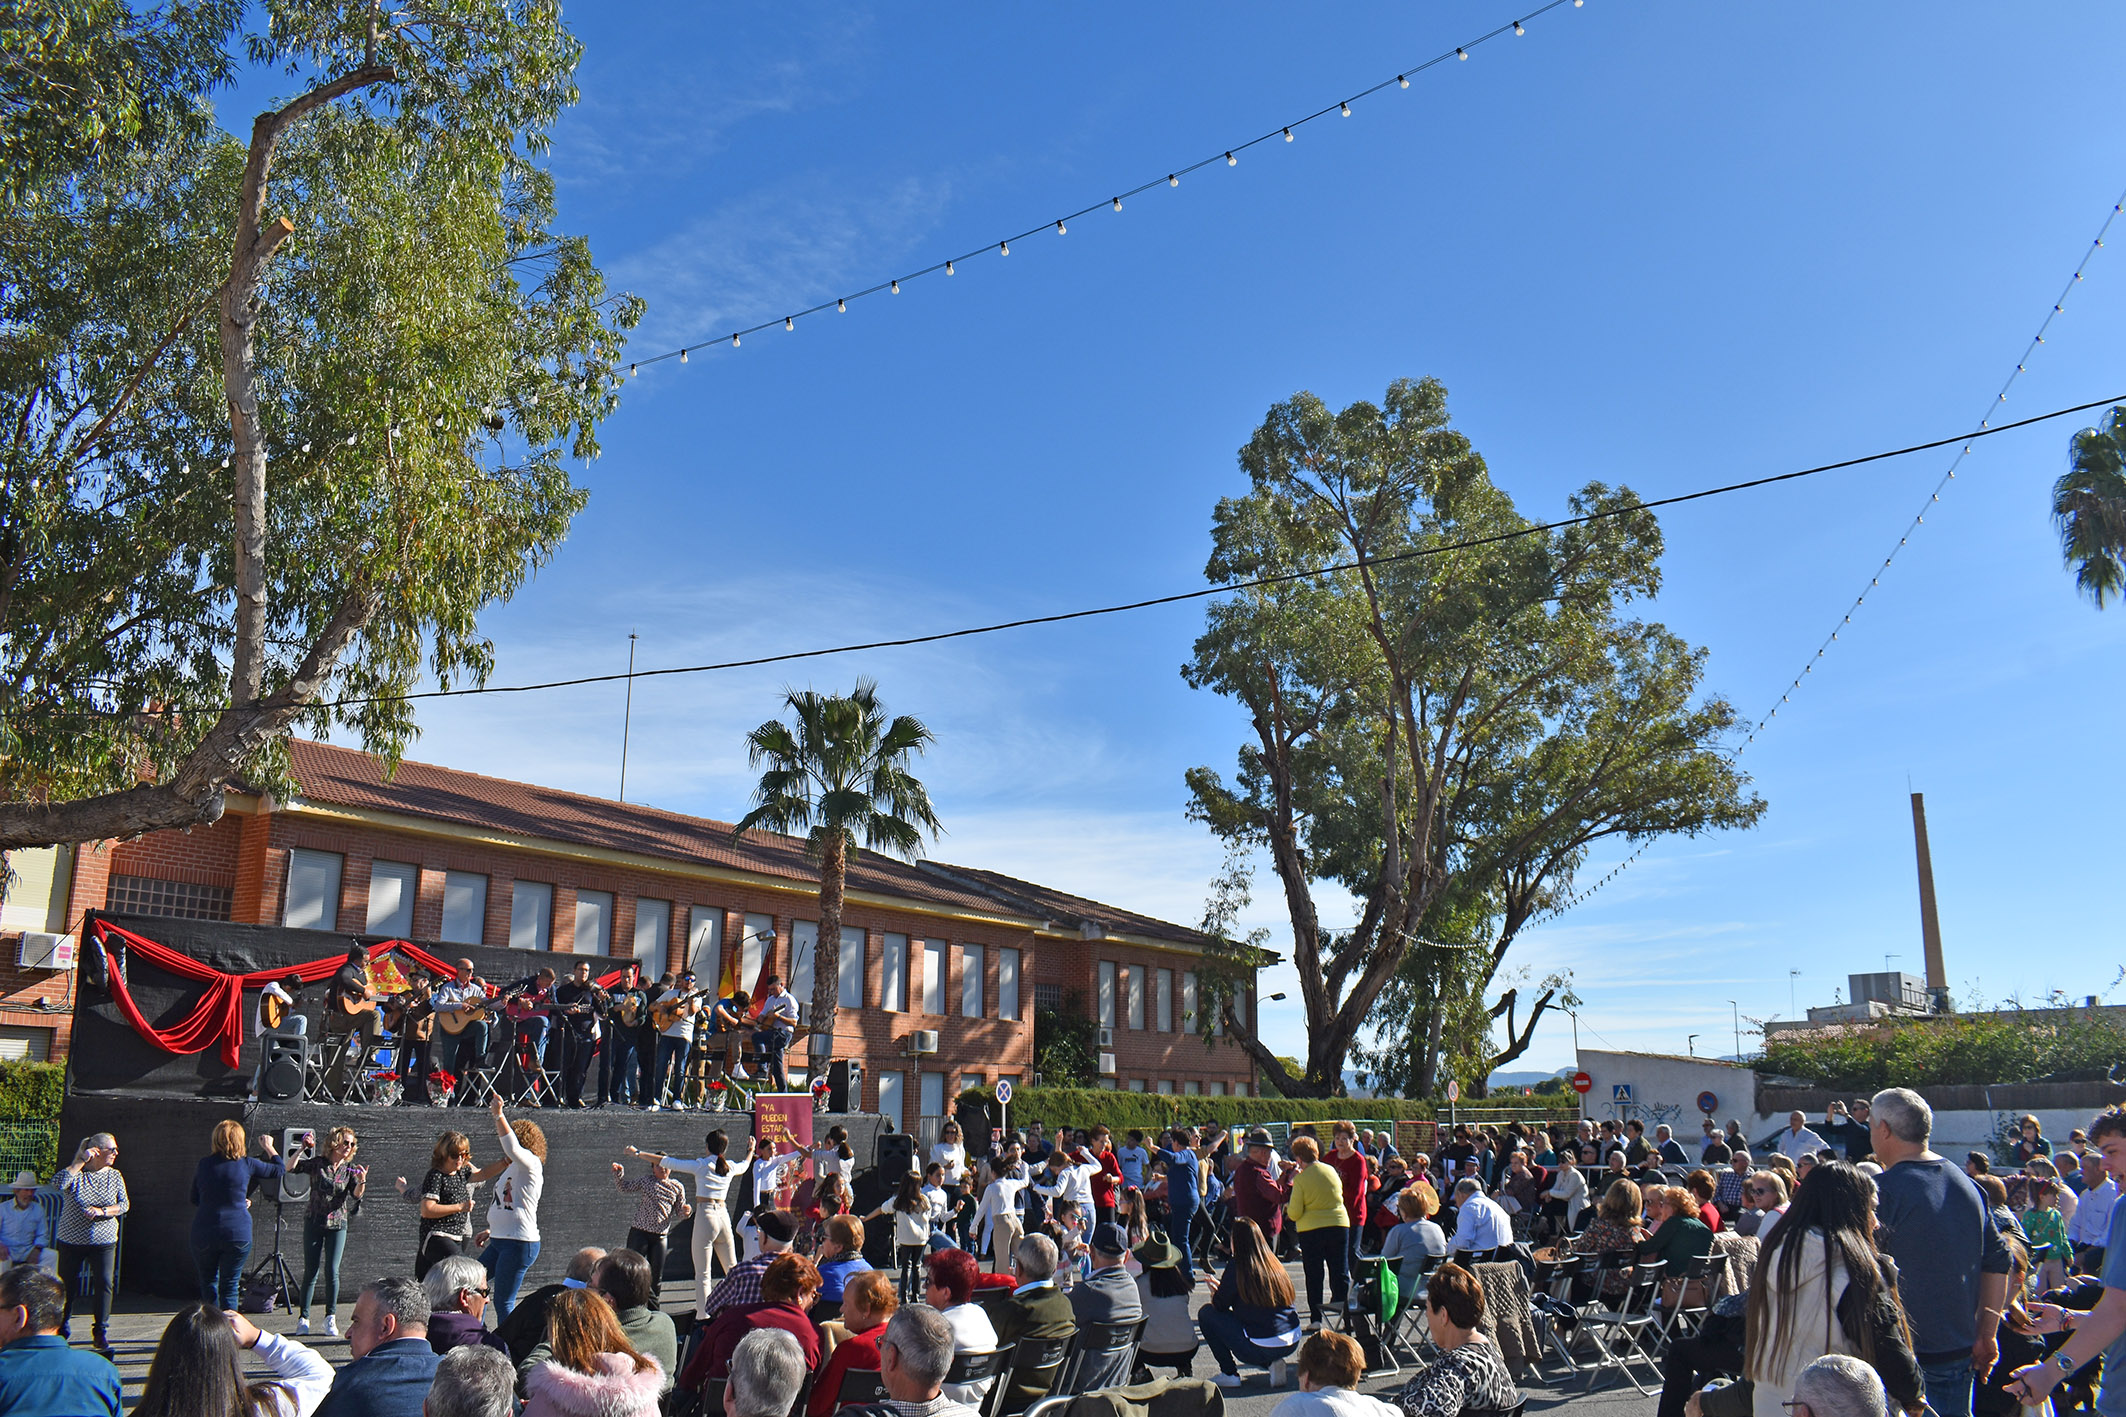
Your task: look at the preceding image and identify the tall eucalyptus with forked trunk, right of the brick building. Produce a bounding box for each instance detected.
[1182,380,1762,1096]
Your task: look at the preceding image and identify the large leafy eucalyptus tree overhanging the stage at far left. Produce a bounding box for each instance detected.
[0,0,642,848]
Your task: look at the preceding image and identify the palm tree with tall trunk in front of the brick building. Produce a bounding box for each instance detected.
[731,680,944,1070]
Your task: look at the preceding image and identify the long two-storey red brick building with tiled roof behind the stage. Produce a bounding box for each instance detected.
[0,741,1254,1128]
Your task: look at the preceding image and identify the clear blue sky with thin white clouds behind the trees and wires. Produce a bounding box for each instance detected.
[282,0,2126,1066]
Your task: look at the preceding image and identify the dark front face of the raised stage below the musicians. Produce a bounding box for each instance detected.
[60,1092,884,1298]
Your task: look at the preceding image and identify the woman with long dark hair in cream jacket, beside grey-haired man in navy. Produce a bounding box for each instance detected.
[1709,1162,1920,1417]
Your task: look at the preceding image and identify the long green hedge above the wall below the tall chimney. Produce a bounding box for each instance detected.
[1758,1009,2126,1092]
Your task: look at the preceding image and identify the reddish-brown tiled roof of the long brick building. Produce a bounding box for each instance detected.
[289,739,1208,945]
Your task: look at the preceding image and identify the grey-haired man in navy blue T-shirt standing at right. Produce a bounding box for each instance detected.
[1862,1088,2011,1417]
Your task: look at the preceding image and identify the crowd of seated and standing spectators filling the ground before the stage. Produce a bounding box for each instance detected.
[0,1088,2126,1417]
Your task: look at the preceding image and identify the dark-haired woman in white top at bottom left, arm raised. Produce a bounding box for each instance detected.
[134,1302,332,1417]
